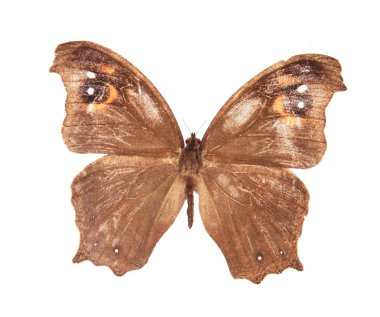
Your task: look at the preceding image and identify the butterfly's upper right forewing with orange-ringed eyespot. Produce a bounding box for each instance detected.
[202,54,346,168]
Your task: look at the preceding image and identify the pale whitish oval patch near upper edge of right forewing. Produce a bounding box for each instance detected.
[223,98,262,131]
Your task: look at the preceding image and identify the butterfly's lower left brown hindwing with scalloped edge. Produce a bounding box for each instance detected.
[72,155,185,275]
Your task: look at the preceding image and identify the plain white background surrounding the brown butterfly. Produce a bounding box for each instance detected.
[0,0,380,316]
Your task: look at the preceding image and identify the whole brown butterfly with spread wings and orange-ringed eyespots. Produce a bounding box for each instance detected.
[50,42,346,283]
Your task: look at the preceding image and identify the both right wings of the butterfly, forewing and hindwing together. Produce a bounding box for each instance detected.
[198,54,345,283]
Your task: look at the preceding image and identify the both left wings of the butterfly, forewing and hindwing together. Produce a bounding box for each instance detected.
[51,42,185,275]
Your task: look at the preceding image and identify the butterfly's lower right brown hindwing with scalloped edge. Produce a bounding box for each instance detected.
[199,164,309,283]
